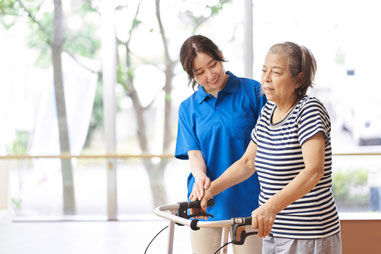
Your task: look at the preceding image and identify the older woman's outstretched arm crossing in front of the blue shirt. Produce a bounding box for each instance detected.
[201,141,257,211]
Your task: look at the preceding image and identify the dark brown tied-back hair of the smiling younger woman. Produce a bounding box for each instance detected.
[180,35,225,90]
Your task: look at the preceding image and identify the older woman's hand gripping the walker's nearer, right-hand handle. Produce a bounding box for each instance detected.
[251,204,276,238]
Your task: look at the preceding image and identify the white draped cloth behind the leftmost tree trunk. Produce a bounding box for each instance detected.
[22,54,100,210]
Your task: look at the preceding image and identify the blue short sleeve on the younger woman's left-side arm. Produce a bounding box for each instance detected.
[175,104,201,160]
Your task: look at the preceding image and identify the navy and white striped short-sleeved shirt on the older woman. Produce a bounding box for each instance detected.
[251,96,340,239]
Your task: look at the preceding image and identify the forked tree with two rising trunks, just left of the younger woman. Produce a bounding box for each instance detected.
[116,0,230,207]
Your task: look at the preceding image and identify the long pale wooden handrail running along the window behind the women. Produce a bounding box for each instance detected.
[0,152,381,160]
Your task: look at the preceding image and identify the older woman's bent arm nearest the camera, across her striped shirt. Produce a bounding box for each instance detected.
[252,132,325,237]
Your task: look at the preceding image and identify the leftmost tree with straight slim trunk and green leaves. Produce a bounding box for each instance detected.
[0,0,99,214]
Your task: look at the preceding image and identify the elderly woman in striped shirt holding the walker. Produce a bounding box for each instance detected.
[202,42,342,254]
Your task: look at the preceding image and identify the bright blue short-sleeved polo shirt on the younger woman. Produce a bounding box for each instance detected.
[175,72,266,220]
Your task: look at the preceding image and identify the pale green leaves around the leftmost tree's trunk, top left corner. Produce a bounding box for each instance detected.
[0,0,101,68]
